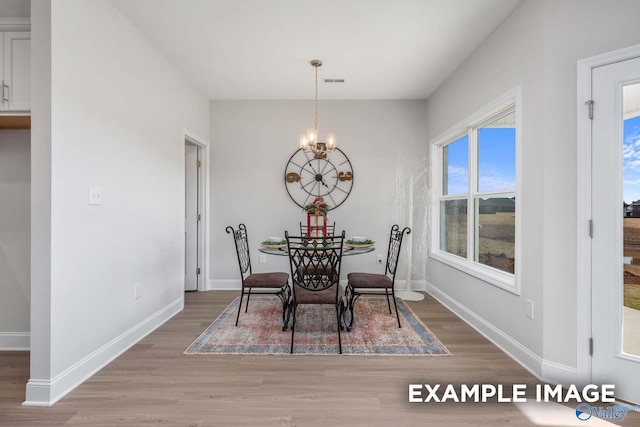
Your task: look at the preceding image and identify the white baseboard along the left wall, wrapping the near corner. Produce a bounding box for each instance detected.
[23,297,184,406]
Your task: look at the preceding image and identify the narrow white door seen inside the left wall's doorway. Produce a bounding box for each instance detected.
[184,142,200,291]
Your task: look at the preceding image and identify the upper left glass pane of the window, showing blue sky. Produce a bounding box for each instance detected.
[442,136,469,195]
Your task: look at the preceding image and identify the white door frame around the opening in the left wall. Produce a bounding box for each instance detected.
[180,129,210,291]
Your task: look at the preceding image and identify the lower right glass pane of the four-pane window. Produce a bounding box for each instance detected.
[475,197,516,273]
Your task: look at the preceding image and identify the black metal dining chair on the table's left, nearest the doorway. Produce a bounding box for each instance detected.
[225,224,291,330]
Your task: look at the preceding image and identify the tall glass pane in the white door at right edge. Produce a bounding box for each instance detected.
[622,83,640,355]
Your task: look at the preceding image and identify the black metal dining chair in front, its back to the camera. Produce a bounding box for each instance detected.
[285,231,344,354]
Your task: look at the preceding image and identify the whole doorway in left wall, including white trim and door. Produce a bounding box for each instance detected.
[184,131,208,291]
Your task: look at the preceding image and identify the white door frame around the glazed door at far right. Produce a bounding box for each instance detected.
[576,44,640,384]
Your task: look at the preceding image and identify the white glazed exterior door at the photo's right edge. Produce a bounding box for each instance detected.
[591,58,640,403]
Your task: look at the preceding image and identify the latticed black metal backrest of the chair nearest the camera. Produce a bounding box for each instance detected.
[285,231,344,295]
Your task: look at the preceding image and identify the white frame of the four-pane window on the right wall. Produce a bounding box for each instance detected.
[430,86,522,295]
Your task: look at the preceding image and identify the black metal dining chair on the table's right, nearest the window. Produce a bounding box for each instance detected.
[345,224,411,330]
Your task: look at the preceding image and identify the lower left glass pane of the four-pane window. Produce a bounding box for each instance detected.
[440,200,467,258]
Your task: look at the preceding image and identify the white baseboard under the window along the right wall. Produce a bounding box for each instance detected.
[426,283,577,384]
